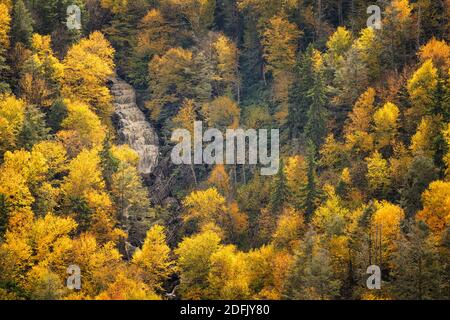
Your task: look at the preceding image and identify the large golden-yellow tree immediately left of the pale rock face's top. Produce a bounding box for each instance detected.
[61,31,114,124]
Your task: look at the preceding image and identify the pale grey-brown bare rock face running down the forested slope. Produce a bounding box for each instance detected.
[110,77,159,175]
